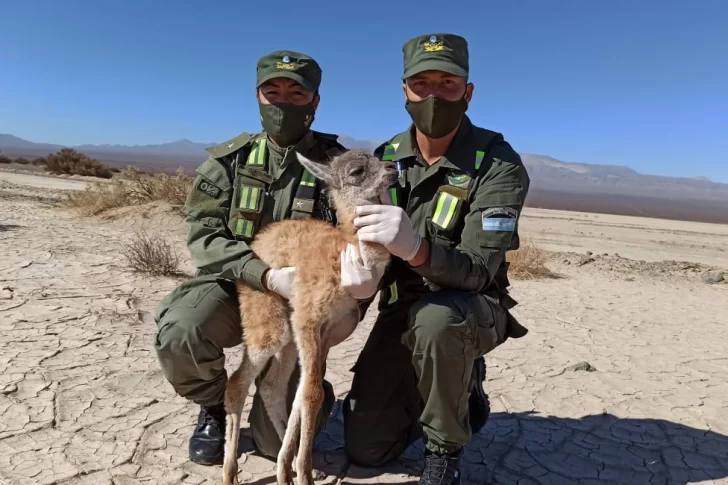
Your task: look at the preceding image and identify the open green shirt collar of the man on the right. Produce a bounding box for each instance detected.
[393,115,475,175]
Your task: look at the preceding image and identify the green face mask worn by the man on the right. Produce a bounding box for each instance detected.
[405,96,468,138]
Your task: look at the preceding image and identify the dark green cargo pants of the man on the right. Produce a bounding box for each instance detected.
[343,291,508,466]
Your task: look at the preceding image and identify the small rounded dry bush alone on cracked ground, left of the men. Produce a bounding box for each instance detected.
[121,230,180,276]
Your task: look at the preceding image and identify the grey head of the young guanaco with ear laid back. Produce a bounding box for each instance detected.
[296,150,397,223]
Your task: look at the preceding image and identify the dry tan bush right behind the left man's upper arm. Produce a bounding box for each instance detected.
[118,166,192,206]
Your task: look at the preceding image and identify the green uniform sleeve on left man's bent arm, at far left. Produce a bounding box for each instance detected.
[184,158,268,290]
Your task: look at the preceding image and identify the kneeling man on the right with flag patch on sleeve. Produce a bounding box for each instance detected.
[344,34,529,485]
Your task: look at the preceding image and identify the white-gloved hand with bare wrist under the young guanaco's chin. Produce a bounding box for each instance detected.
[354,195,422,261]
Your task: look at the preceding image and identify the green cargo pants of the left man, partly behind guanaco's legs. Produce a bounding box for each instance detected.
[154,276,335,458]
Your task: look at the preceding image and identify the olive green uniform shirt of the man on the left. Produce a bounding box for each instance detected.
[178,131,346,290]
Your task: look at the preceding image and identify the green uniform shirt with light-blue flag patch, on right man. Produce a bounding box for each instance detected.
[375,116,530,305]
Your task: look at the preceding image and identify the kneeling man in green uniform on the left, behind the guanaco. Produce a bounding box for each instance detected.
[154,51,376,464]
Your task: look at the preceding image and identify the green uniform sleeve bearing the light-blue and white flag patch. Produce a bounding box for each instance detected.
[413,142,530,292]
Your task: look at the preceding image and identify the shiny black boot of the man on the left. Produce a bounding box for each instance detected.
[189,404,225,465]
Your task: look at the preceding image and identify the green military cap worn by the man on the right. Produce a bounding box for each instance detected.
[402,34,469,79]
